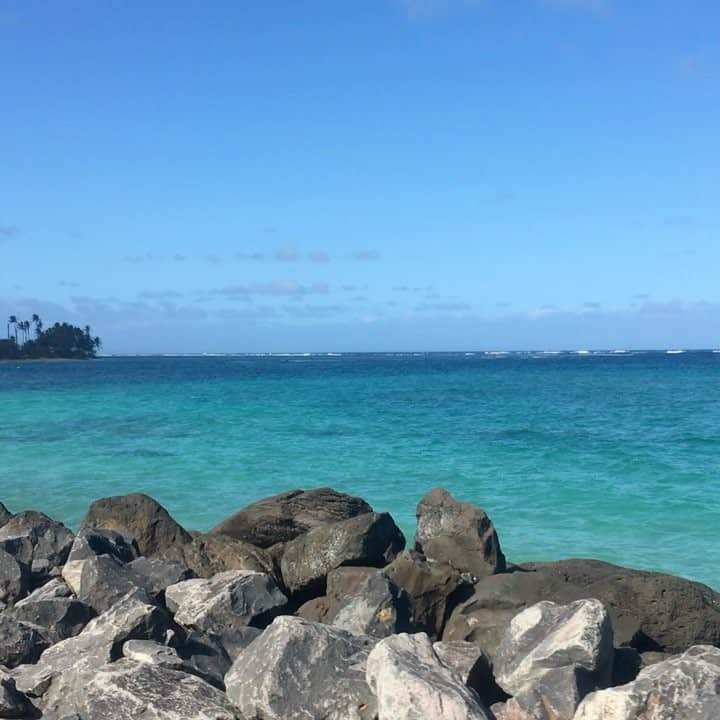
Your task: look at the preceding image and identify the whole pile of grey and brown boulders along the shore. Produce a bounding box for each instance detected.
[0,489,720,720]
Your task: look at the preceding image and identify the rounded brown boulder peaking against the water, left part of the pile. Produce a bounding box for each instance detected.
[81,493,192,555]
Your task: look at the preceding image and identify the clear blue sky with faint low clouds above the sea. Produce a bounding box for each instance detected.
[0,0,720,353]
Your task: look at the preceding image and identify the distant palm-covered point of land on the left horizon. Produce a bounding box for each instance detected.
[0,315,102,360]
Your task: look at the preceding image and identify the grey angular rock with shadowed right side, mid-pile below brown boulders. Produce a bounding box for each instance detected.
[328,568,412,638]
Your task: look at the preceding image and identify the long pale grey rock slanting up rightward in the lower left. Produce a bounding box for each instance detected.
[13,591,168,709]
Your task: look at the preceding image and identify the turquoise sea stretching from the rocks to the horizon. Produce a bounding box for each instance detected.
[0,352,720,588]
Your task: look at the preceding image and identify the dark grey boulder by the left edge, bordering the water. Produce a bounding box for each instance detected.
[0,510,74,583]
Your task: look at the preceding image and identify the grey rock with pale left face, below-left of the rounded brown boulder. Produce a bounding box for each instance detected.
[62,555,140,613]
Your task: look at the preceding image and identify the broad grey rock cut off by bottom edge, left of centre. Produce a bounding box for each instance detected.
[75,659,237,720]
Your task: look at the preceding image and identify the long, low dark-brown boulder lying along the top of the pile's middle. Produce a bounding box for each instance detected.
[210,488,372,548]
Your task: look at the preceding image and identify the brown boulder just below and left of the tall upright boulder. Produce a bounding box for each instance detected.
[384,550,473,638]
